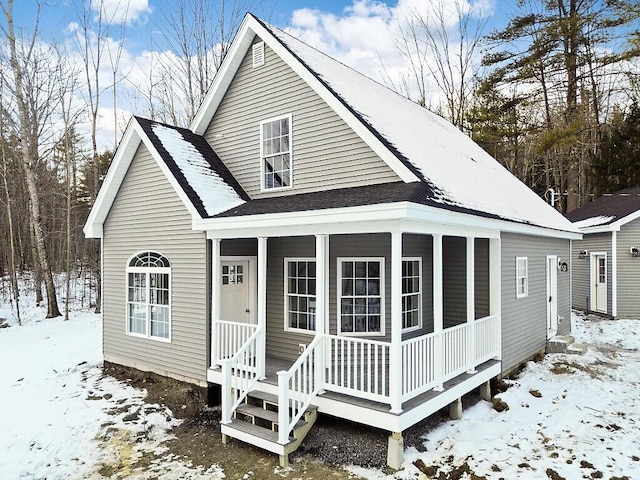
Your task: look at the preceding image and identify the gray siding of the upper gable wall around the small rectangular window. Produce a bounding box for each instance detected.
[205,35,399,198]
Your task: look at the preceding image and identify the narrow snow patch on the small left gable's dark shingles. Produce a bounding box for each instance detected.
[151,123,245,216]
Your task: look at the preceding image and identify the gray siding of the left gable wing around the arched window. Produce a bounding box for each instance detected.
[103,146,209,384]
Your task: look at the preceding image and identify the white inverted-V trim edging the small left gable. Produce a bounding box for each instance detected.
[83,117,200,238]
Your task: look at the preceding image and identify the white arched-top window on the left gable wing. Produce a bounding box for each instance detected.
[127,252,171,340]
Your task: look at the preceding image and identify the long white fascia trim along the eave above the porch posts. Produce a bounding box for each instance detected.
[193,202,582,240]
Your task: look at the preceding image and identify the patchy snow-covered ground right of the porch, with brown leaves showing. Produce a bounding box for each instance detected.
[351,314,640,480]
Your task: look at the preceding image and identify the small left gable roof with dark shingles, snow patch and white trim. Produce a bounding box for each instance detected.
[84,116,249,237]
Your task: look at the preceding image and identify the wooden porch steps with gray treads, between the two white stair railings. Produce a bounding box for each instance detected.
[220,390,318,466]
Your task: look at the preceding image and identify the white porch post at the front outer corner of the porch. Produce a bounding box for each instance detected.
[389,231,403,413]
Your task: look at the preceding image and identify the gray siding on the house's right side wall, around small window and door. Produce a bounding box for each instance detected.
[501,233,571,371]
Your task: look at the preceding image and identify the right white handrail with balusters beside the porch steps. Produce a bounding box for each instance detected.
[278,335,324,445]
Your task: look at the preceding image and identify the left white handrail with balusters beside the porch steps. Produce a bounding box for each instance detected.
[221,329,260,423]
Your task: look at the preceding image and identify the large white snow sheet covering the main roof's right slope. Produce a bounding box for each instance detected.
[267,26,577,232]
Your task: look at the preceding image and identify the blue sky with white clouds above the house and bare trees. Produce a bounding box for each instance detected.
[6,0,516,149]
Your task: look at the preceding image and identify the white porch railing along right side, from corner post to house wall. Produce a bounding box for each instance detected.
[401,316,500,402]
